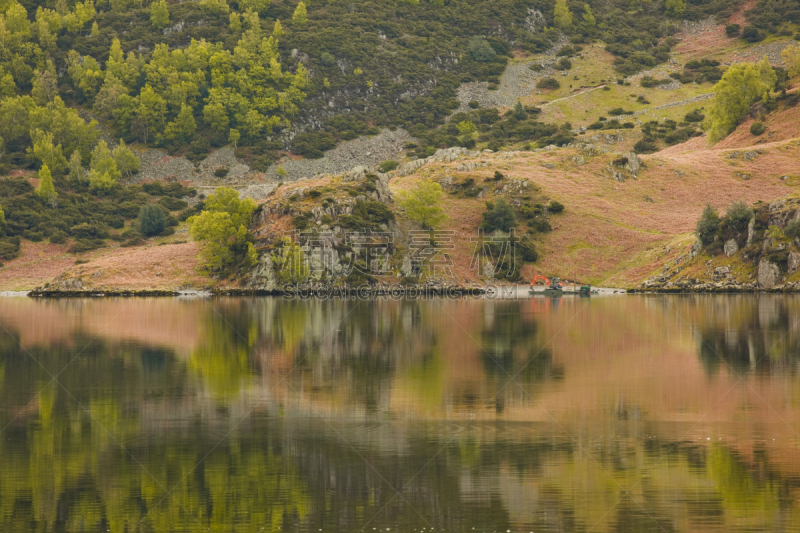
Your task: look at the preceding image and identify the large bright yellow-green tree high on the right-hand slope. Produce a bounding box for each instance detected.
[707,57,777,143]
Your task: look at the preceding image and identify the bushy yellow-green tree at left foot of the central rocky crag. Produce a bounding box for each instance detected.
[187,187,258,271]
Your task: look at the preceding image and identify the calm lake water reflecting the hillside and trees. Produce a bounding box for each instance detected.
[0,295,800,533]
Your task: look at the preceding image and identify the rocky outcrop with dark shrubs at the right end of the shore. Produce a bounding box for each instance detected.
[642,194,800,292]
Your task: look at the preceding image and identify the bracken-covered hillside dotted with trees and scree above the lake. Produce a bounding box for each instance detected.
[0,0,800,290]
